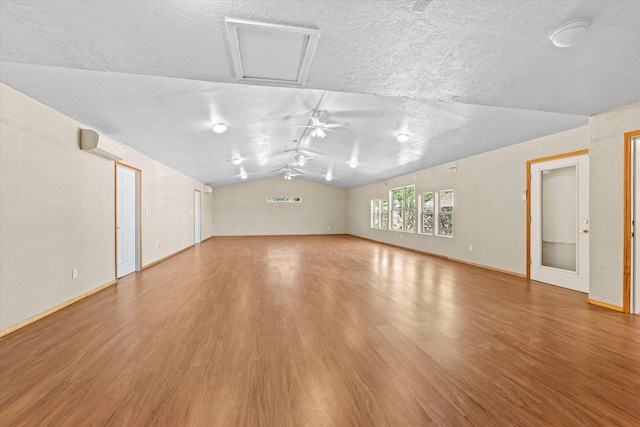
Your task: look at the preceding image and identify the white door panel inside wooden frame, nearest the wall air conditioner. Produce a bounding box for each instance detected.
[116,165,137,278]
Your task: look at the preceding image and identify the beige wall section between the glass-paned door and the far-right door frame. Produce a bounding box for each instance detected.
[589,103,640,306]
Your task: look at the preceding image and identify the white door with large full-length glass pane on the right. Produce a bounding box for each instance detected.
[530,155,589,292]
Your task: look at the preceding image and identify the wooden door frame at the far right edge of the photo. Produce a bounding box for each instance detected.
[622,130,640,313]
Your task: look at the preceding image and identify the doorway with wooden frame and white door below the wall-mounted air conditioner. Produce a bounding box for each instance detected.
[116,163,141,279]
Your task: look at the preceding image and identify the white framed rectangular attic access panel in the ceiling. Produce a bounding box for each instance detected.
[225,18,320,86]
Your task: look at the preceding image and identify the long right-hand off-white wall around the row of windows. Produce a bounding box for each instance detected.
[348,126,589,274]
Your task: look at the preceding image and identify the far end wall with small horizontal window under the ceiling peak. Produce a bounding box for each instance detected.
[213,177,347,236]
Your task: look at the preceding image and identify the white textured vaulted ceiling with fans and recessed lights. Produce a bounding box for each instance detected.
[0,0,640,188]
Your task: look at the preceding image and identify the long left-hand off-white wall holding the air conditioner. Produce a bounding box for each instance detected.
[0,84,211,330]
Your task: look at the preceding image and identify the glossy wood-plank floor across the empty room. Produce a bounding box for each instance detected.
[0,236,640,427]
